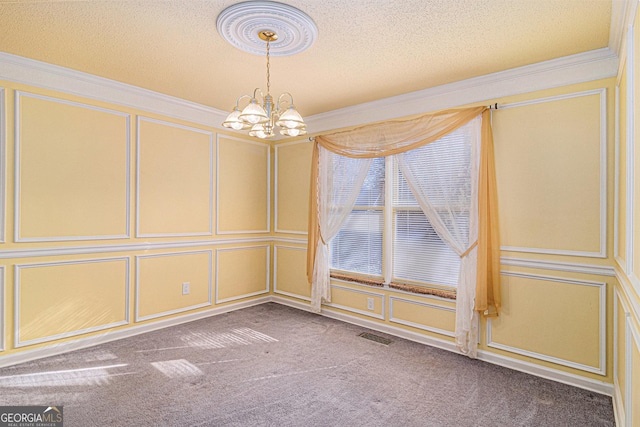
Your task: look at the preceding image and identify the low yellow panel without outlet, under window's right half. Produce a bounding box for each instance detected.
[389,296,456,337]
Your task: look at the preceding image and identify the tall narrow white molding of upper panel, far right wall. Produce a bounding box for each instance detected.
[625,25,640,280]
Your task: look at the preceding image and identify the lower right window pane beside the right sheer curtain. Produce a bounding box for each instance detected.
[393,210,460,286]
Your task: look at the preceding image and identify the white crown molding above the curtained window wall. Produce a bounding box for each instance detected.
[305,47,618,133]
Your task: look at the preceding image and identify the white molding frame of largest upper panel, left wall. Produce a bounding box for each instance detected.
[13,90,131,243]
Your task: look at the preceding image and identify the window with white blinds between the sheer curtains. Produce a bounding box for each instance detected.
[330,126,471,287]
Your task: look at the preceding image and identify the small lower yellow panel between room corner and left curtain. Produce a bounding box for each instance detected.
[273,245,311,301]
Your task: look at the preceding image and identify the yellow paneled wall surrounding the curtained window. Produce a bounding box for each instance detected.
[274,79,616,392]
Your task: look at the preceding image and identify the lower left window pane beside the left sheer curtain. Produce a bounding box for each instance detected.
[329,210,384,276]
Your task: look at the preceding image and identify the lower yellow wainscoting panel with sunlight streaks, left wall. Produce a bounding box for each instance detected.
[14,257,129,347]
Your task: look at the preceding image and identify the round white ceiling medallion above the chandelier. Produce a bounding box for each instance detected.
[216,1,318,56]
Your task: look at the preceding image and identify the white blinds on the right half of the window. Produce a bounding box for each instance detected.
[393,125,471,286]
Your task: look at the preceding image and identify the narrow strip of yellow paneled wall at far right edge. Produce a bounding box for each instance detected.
[613,3,640,426]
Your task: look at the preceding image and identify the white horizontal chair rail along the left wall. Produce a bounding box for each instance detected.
[0,237,272,259]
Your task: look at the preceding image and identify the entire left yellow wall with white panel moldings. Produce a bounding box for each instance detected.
[0,81,271,365]
